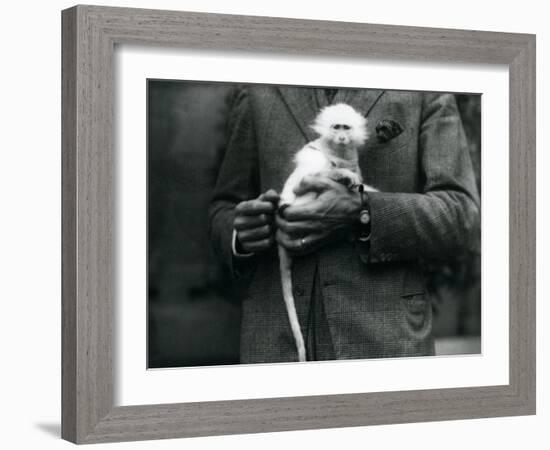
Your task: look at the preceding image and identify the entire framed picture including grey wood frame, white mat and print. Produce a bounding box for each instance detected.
[62,6,536,443]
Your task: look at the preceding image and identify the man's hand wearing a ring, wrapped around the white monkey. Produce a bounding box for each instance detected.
[276,175,361,254]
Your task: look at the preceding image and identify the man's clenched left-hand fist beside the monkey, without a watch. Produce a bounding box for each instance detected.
[233,189,279,253]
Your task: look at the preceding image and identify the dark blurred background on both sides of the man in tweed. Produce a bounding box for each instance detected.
[147,80,481,368]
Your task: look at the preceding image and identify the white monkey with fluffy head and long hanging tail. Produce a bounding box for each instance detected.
[279,103,376,361]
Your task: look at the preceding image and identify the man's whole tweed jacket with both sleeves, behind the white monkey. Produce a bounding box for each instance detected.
[209,86,479,363]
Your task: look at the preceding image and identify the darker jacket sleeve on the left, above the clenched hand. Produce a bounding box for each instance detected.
[208,88,259,276]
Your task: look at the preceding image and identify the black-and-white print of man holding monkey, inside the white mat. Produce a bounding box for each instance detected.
[147,79,483,369]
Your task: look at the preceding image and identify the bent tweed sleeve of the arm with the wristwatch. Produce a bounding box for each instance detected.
[368,94,480,262]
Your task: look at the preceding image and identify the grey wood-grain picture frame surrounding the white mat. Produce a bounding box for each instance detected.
[62,6,535,443]
